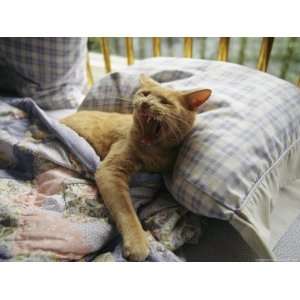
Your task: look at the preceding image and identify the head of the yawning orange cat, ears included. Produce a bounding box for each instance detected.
[133,75,211,146]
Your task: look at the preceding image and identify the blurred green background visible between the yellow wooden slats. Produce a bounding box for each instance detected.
[88,37,300,82]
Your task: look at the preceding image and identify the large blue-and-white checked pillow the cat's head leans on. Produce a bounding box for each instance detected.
[80,58,300,258]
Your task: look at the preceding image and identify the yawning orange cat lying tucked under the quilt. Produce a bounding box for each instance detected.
[62,75,211,261]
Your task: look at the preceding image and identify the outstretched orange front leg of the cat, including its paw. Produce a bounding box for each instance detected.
[95,145,149,261]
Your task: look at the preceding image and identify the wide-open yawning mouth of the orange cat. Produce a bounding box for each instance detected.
[138,112,161,145]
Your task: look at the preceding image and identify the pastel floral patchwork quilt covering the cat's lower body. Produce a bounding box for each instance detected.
[0,97,202,261]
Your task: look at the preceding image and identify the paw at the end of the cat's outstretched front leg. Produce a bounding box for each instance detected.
[123,232,150,261]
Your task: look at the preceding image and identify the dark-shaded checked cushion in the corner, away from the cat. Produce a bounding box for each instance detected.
[0,37,87,109]
